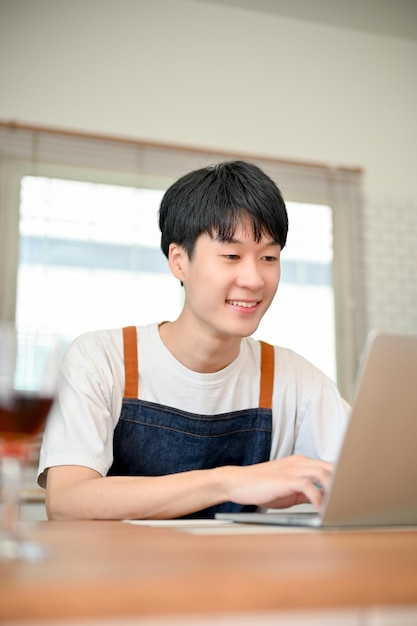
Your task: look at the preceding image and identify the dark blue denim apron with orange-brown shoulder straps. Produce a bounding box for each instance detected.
[108,326,274,518]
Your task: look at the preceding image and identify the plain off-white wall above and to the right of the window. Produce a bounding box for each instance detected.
[0,0,417,332]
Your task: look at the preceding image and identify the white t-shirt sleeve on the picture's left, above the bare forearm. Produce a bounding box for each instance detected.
[38,334,122,487]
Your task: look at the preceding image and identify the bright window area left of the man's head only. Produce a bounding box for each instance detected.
[16,176,182,338]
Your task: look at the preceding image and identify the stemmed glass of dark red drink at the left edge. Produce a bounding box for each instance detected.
[0,323,60,561]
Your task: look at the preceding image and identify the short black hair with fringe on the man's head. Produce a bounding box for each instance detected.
[159,161,288,258]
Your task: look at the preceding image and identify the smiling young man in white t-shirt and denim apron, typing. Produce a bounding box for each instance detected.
[39,161,348,519]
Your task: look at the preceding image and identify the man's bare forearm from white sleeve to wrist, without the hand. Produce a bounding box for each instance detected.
[46,467,225,520]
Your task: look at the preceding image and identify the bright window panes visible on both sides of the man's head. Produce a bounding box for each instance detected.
[16,176,336,379]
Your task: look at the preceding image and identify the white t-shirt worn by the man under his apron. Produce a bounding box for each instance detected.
[38,323,349,486]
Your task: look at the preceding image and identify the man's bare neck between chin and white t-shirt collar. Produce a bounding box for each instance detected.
[159,316,241,374]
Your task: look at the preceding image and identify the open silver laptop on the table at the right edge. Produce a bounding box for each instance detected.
[216,332,417,528]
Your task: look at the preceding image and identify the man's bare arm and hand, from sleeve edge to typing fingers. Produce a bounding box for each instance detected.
[46,456,333,520]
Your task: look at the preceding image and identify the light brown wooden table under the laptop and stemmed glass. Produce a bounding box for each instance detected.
[0,522,417,624]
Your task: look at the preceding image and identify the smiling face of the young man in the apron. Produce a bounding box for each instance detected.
[171,217,281,337]
